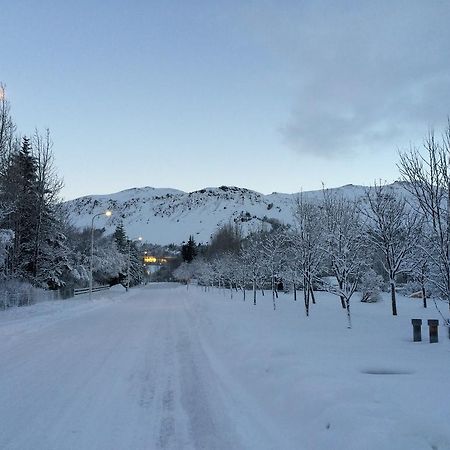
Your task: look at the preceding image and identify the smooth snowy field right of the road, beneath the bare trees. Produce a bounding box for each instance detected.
[187,290,450,450]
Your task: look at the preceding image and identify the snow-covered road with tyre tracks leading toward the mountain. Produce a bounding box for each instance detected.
[0,288,267,450]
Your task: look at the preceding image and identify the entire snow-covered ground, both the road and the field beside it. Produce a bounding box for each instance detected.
[0,284,450,450]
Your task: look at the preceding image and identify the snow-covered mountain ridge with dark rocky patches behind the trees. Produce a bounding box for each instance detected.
[65,183,404,244]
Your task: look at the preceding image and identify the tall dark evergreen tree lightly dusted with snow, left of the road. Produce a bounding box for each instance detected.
[0,132,68,288]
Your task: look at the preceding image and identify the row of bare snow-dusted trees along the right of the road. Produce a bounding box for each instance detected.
[175,121,450,326]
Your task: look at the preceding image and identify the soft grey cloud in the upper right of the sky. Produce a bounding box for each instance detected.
[244,0,450,157]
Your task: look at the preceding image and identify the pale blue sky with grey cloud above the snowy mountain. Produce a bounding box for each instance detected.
[0,0,450,199]
